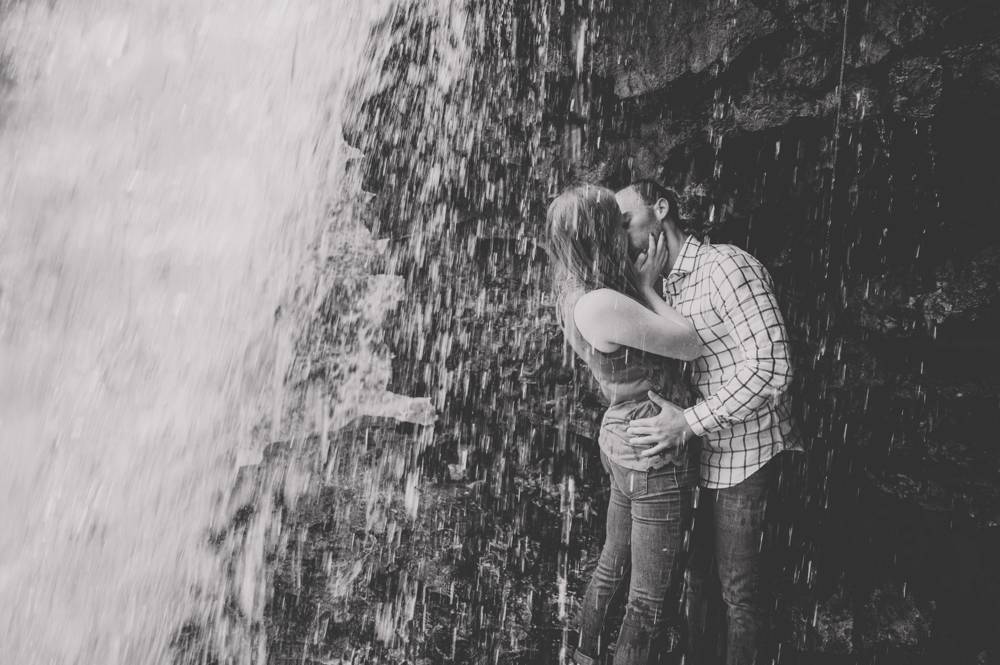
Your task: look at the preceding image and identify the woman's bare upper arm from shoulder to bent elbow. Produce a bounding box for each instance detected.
[573,289,703,360]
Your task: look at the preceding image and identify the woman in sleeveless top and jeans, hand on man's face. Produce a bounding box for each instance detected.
[547,185,701,665]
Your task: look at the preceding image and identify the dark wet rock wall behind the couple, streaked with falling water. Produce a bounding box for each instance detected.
[262,0,1000,663]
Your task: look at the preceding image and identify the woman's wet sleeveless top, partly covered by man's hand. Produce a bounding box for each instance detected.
[559,290,693,471]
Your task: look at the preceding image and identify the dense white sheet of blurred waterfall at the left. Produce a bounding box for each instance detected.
[0,0,410,665]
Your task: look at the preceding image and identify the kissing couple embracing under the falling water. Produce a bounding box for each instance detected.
[546,180,797,665]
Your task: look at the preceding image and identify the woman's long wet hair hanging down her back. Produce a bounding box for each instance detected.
[546,185,637,309]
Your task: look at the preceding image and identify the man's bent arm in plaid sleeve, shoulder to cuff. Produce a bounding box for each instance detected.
[684,252,792,436]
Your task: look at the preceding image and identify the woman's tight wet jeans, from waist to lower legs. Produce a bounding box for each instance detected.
[574,453,698,665]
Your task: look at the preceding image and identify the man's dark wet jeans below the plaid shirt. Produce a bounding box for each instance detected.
[686,459,778,665]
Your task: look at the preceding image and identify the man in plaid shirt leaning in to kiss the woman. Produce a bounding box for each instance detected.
[616,180,796,665]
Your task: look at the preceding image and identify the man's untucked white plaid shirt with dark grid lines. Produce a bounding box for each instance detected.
[664,236,797,489]
